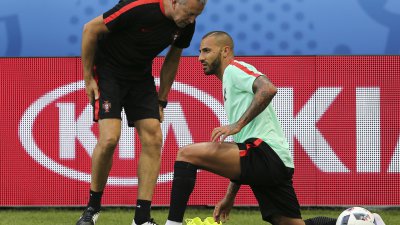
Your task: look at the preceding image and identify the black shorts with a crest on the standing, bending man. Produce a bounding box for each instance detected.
[93,66,160,127]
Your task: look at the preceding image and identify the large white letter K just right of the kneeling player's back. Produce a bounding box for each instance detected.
[273,88,349,172]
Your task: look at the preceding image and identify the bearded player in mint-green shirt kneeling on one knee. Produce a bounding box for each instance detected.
[162,31,336,225]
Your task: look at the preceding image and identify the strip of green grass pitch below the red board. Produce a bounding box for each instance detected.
[0,207,400,225]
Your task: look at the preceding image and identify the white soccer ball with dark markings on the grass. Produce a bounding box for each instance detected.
[336,207,375,225]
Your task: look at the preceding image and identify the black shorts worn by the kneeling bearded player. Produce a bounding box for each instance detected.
[233,138,301,223]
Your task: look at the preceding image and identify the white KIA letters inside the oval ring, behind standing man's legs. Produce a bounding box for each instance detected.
[57,103,193,159]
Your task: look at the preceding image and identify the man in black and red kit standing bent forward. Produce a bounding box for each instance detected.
[77,0,207,225]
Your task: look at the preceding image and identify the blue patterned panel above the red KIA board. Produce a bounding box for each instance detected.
[0,0,400,56]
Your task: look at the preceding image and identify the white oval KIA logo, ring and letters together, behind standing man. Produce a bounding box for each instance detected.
[18,78,227,186]
